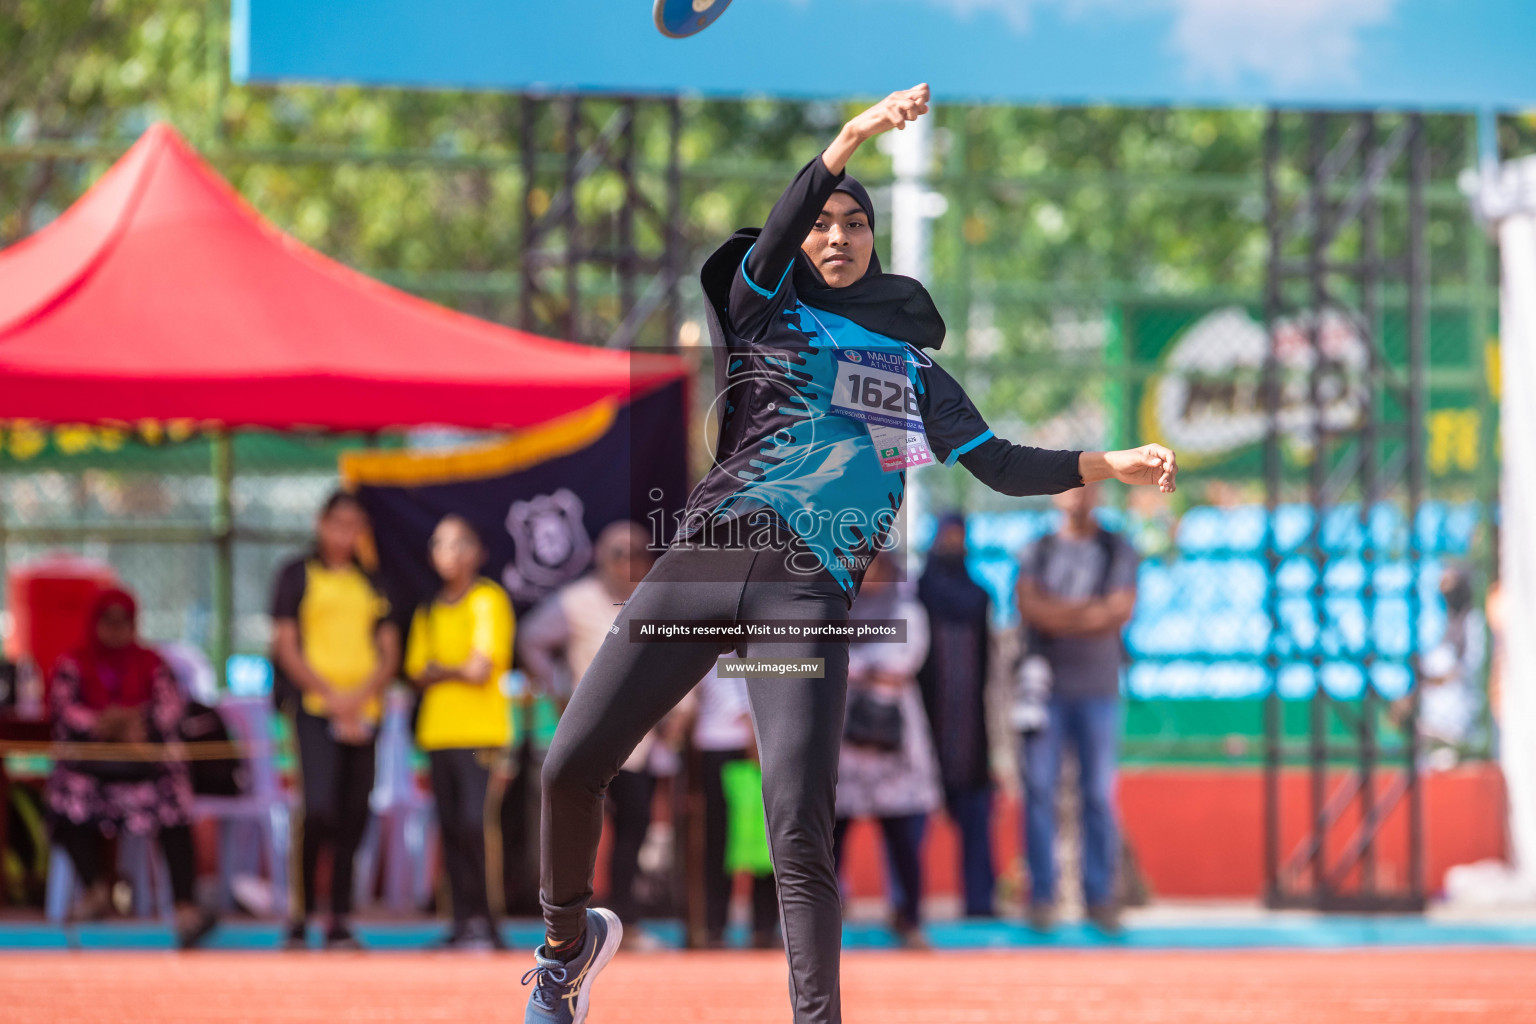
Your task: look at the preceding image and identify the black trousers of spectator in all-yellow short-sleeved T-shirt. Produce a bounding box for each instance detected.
[427,749,495,924]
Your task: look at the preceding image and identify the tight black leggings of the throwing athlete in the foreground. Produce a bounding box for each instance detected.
[539,547,848,1024]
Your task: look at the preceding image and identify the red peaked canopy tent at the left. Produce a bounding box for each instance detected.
[0,124,687,430]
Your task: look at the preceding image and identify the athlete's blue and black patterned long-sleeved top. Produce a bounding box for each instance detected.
[679,157,1083,602]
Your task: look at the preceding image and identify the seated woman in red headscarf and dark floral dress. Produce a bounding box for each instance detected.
[48,588,215,949]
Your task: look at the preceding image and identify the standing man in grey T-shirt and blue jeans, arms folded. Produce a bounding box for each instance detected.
[1015,484,1138,930]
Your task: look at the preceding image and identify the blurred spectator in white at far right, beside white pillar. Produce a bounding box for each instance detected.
[1395,567,1487,769]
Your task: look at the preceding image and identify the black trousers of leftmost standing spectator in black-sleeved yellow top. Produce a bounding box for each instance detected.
[293,709,376,918]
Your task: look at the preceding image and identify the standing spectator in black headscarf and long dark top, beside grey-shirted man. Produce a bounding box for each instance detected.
[917,513,995,917]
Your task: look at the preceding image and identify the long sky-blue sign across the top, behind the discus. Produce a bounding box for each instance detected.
[230,0,1536,109]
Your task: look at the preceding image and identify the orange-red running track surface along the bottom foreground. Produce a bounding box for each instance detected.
[0,949,1536,1024]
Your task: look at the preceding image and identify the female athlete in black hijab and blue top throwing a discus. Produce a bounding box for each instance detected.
[524,84,1178,1024]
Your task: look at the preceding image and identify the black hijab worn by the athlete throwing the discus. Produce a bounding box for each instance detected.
[700,175,945,348]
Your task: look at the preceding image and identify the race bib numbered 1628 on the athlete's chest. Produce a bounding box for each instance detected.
[833,348,934,473]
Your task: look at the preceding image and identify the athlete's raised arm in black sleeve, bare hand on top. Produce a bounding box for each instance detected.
[746,84,928,292]
